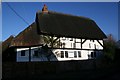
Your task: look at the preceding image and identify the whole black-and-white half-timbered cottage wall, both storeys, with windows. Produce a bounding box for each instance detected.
[16,37,103,62]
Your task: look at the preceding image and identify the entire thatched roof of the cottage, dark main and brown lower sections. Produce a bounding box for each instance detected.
[5,11,106,47]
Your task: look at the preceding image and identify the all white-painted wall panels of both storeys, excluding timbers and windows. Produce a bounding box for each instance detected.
[16,37,103,62]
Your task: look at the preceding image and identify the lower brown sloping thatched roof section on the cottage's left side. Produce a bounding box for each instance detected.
[11,22,43,46]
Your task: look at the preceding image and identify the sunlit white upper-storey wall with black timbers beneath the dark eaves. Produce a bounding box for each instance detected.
[60,37,103,50]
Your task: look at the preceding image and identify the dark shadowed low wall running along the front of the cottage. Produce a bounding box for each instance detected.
[2,60,96,79]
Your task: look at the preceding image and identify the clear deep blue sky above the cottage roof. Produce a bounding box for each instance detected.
[2,2,120,41]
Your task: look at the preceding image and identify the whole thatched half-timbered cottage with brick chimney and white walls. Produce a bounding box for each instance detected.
[3,5,106,62]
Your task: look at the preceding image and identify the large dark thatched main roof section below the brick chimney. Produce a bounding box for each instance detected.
[36,11,106,39]
